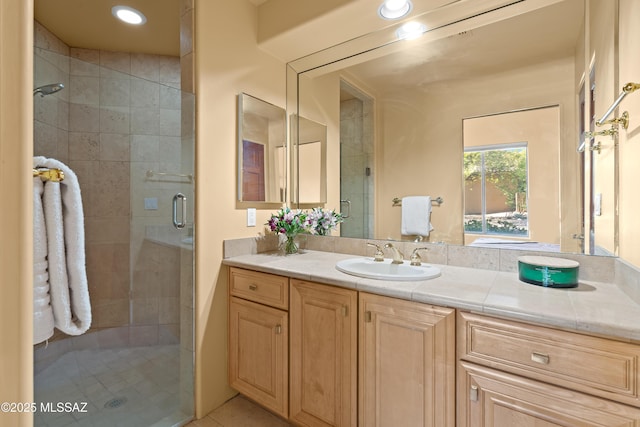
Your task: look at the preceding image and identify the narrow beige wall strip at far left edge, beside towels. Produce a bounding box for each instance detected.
[0,0,33,427]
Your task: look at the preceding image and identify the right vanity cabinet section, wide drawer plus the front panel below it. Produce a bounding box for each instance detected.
[457,312,640,427]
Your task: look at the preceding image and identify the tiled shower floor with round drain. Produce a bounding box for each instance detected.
[34,345,186,427]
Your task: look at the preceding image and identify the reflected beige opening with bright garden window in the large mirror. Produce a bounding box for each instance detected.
[463,106,564,252]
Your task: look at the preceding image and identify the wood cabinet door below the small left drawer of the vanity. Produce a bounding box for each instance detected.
[229,297,289,418]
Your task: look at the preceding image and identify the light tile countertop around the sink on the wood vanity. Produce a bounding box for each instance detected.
[223,250,640,342]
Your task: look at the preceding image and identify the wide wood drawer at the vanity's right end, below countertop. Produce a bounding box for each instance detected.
[457,312,640,407]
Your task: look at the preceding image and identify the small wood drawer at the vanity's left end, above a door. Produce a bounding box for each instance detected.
[229,267,289,310]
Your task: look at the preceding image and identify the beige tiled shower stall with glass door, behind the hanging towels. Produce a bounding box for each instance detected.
[34,22,195,427]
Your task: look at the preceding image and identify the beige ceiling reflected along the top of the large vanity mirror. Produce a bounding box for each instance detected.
[349,0,584,90]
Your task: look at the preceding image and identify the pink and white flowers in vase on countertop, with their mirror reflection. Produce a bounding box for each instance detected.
[266,208,344,254]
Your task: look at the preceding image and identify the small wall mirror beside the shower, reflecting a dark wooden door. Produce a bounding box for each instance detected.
[238,93,287,206]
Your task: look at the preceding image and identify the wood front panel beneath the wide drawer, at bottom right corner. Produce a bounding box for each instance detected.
[458,362,640,427]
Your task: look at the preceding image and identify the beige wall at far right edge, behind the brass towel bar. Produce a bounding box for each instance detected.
[618,0,640,266]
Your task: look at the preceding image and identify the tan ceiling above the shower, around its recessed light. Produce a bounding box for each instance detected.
[34,0,181,56]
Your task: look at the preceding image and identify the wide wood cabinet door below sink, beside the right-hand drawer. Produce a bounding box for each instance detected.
[359,293,456,427]
